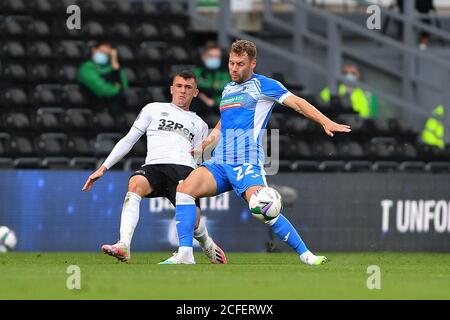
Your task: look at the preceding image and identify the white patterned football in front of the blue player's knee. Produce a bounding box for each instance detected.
[248,187,283,221]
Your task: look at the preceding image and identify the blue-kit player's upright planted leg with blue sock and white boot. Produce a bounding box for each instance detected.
[161,163,231,264]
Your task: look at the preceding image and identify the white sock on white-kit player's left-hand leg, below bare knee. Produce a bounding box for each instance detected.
[120,192,142,249]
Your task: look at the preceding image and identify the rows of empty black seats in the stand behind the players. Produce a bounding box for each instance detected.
[0,0,450,172]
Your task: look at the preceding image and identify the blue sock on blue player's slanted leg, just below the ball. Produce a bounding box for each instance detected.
[268,214,309,255]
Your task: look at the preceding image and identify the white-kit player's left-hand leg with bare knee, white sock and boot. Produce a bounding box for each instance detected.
[102,175,154,262]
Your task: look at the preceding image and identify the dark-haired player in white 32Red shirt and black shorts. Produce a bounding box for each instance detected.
[82,70,227,264]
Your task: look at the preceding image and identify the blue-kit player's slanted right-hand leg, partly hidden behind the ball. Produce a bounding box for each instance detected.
[244,185,327,265]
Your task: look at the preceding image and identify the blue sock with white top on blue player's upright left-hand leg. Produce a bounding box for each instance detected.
[175,192,197,247]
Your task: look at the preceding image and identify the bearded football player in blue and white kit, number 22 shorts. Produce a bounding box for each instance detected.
[161,40,351,265]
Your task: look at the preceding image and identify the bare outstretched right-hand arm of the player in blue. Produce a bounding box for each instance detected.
[283,95,352,137]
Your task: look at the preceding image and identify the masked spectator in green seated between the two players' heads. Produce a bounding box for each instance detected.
[192,42,230,113]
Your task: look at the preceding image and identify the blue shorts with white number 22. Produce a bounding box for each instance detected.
[201,158,267,196]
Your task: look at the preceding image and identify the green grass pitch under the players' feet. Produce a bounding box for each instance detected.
[0,252,450,300]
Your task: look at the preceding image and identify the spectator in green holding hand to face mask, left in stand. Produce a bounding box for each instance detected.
[77,41,128,112]
